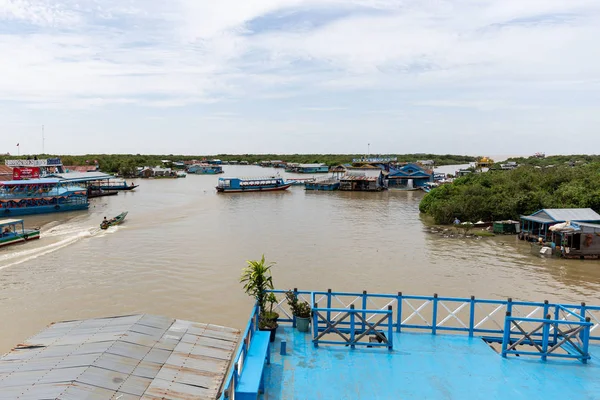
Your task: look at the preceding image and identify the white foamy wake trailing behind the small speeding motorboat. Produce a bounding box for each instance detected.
[0,226,119,270]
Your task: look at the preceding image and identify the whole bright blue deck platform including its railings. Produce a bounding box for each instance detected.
[222,290,600,400]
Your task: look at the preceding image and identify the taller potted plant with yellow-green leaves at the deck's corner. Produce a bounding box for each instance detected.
[240,254,279,342]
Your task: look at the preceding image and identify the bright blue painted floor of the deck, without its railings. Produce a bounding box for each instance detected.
[261,327,600,400]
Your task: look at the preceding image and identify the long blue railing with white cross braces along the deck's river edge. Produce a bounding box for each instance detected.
[272,290,600,342]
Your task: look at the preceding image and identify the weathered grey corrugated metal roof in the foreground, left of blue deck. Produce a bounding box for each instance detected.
[0,315,240,400]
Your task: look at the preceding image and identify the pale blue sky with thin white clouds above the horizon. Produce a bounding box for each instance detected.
[0,0,600,155]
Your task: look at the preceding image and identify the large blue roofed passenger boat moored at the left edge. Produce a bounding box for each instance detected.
[0,178,89,217]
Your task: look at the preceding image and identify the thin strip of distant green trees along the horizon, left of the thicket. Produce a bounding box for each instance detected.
[0,154,475,175]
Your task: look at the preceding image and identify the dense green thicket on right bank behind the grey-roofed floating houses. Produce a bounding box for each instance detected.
[419,162,600,224]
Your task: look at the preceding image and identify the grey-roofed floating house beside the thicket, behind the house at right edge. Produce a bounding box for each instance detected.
[519,208,600,242]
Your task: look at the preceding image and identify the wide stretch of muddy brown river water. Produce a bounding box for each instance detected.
[0,166,600,353]
